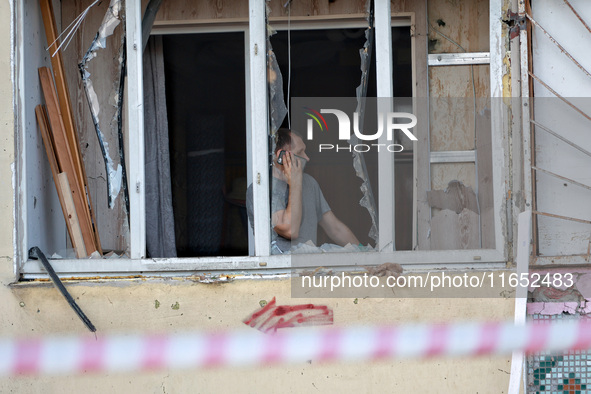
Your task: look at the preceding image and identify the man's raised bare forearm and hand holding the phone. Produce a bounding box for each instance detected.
[271,151,304,239]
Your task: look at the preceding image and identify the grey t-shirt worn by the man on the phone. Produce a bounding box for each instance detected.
[246,173,330,252]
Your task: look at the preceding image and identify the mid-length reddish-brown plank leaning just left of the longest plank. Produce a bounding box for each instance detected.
[39,67,97,254]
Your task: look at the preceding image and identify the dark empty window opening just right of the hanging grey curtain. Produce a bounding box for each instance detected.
[164,32,248,257]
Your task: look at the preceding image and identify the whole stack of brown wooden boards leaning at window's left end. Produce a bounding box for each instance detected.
[35,0,102,258]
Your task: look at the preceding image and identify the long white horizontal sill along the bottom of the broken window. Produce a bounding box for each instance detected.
[20,249,506,280]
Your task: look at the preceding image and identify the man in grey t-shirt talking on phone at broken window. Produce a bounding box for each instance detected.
[246,128,359,254]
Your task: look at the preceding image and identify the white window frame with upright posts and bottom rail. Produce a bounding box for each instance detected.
[15,0,508,278]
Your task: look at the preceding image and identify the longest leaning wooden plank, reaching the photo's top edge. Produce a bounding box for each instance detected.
[39,0,102,254]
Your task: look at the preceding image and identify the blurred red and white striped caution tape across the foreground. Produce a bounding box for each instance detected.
[0,320,591,376]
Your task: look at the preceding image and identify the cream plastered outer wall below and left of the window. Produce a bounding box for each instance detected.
[0,0,513,393]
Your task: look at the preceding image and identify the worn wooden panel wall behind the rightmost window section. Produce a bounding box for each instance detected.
[417,1,498,250]
